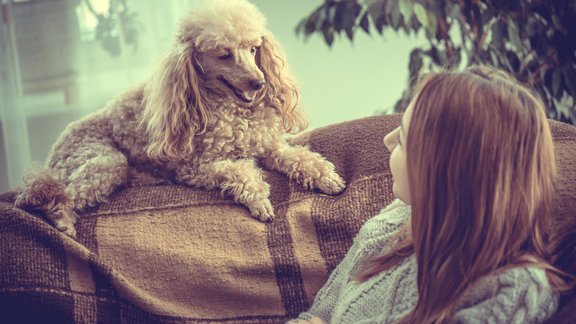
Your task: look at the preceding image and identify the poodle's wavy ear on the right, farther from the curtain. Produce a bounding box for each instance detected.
[256,33,308,133]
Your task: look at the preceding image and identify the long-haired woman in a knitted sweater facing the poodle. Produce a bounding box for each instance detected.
[294,67,571,324]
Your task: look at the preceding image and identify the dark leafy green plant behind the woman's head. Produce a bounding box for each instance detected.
[296,0,576,124]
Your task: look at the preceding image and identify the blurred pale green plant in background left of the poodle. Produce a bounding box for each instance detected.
[84,0,142,56]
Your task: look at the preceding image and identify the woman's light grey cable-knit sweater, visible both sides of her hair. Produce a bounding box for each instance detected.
[299,200,558,323]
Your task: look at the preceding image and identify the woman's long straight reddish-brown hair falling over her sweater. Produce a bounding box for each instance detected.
[355,67,570,323]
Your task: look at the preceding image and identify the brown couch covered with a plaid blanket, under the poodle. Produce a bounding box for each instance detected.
[0,115,576,323]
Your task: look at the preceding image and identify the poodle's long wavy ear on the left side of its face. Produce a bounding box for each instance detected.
[140,42,209,160]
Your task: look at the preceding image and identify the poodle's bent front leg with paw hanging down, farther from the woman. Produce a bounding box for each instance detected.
[176,159,274,222]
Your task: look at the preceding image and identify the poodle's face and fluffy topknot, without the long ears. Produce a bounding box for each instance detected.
[179,0,267,107]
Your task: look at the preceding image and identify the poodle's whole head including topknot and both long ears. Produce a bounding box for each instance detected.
[142,0,306,159]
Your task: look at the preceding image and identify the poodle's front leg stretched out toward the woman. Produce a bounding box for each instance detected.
[263,142,345,195]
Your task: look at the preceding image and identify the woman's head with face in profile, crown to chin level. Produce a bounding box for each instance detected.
[384,66,555,213]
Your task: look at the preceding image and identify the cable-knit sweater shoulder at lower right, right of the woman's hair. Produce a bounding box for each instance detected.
[453,267,558,323]
